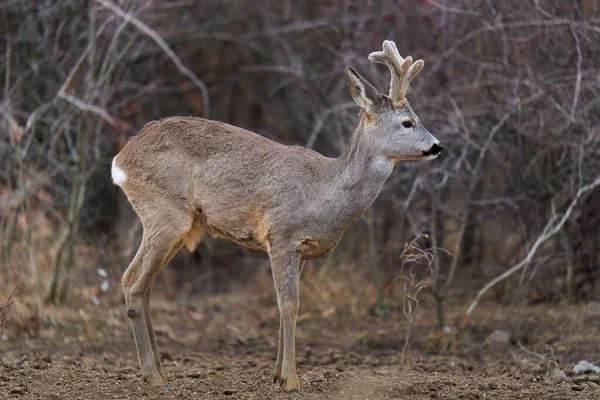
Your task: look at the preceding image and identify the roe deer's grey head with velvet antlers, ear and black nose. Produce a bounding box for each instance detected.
[347,40,442,162]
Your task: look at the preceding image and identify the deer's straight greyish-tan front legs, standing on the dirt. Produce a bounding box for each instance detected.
[269,249,300,392]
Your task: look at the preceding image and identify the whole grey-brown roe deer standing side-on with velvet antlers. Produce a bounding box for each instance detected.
[112,40,442,391]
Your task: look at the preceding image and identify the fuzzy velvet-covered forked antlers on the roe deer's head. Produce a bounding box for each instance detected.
[369,40,425,103]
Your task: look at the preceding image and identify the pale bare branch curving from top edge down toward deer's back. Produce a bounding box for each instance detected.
[95,0,209,118]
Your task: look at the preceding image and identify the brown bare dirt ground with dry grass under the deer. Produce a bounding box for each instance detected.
[0,290,600,400]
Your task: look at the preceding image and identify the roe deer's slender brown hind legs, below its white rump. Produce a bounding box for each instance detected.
[122,207,191,386]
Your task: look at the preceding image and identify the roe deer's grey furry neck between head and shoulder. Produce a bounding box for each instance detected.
[332,123,394,221]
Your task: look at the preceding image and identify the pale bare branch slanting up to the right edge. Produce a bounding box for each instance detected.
[465,176,600,318]
